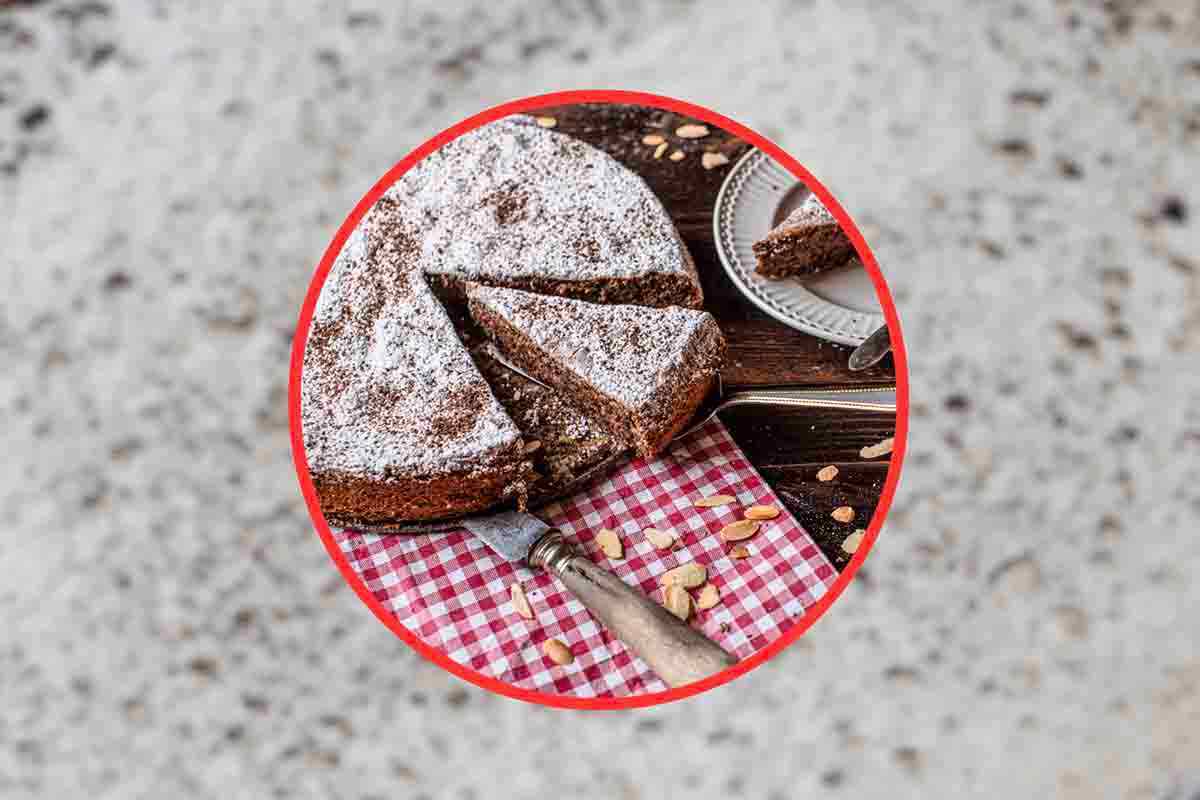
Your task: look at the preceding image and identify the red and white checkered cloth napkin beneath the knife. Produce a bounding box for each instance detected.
[334,420,836,697]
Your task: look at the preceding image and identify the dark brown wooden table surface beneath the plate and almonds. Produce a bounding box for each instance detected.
[539,104,895,570]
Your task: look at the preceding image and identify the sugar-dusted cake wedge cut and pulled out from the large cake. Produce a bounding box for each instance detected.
[467,284,725,457]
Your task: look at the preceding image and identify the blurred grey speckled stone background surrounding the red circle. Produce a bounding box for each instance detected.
[0,0,1200,800]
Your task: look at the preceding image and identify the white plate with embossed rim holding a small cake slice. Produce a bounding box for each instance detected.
[713,150,883,345]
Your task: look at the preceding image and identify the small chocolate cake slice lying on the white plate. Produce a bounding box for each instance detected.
[752,194,854,278]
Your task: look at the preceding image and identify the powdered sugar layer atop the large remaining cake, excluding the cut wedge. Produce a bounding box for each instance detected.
[301,115,698,477]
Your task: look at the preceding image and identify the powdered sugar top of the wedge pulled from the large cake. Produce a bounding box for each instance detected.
[469,287,720,408]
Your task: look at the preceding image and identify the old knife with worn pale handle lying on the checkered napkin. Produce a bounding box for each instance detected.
[460,511,737,687]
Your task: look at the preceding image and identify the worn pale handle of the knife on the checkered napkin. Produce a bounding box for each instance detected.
[528,530,737,686]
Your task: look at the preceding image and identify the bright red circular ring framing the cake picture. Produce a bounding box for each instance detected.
[288,90,908,709]
